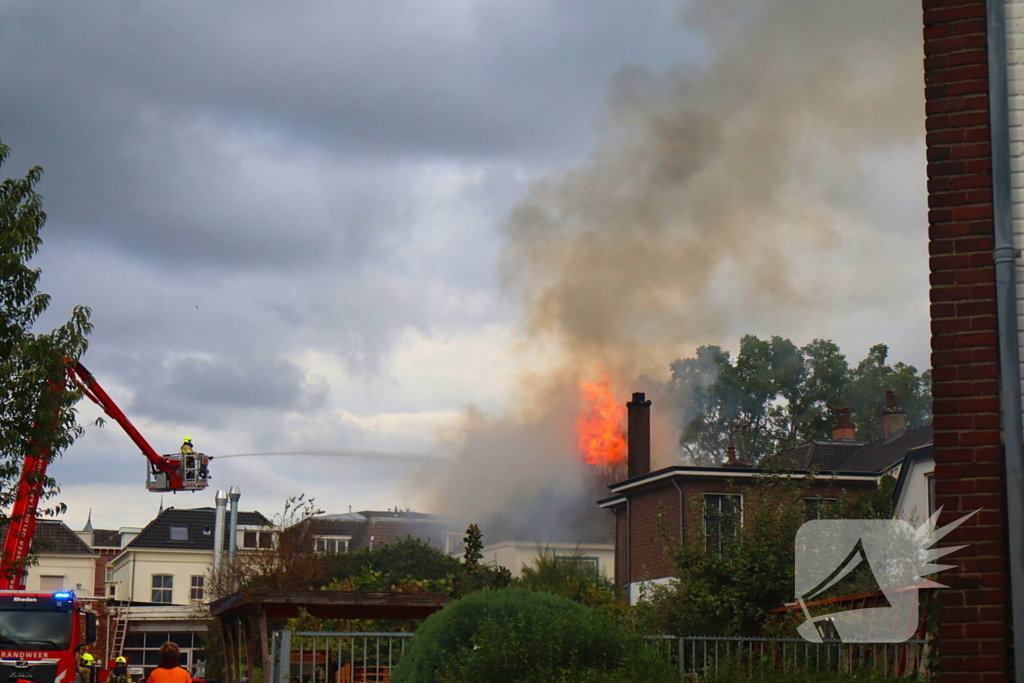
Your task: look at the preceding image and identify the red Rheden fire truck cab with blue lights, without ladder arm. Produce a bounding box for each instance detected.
[0,591,96,683]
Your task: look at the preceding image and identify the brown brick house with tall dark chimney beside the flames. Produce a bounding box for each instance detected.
[598,392,932,604]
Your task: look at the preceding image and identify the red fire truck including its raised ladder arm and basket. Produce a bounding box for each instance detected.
[0,360,212,683]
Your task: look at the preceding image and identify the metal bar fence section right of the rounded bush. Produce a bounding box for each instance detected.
[648,636,929,681]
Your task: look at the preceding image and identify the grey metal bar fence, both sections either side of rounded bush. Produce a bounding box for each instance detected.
[269,630,929,683]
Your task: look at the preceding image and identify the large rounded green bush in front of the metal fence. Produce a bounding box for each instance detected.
[392,589,677,683]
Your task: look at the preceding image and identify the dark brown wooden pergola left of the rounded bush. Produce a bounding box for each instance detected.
[210,590,452,683]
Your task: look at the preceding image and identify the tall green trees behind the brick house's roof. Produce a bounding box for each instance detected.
[662,335,931,463]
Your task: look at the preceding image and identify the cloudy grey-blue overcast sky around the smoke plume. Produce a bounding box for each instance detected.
[0,0,928,528]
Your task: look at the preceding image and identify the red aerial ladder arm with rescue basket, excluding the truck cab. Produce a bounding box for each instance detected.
[0,360,210,591]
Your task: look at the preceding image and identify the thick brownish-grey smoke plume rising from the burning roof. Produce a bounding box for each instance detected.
[411,0,924,544]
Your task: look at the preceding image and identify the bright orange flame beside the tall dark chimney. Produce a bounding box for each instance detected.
[577,373,626,465]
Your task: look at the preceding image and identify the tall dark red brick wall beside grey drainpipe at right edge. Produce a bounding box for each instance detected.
[923,0,1009,683]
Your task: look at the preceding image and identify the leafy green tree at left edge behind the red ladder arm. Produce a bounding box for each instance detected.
[0,142,92,573]
